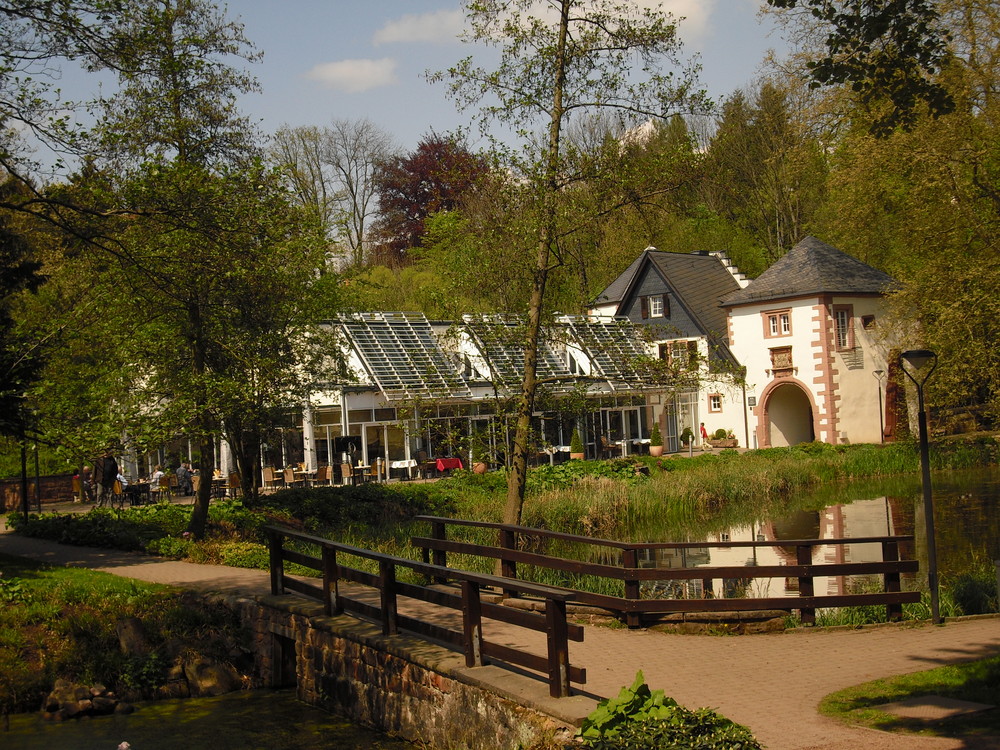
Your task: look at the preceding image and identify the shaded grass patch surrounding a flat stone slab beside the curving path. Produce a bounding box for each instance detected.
[819,655,1000,740]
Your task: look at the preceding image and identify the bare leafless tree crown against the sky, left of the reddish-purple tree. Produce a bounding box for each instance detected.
[274,119,396,266]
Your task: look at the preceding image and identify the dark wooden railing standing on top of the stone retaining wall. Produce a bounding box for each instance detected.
[265,526,587,698]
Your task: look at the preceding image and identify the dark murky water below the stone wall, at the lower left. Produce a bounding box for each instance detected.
[0,689,414,750]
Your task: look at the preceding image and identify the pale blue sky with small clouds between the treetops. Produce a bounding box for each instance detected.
[227,0,783,150]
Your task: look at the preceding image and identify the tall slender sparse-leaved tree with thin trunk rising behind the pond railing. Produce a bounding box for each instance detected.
[432,0,700,523]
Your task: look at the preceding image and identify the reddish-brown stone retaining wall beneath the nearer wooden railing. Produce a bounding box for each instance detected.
[223,596,593,750]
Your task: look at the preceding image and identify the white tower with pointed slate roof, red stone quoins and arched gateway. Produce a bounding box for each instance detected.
[722,237,893,447]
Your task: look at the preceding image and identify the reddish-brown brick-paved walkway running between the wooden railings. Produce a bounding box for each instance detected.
[0,516,1000,750]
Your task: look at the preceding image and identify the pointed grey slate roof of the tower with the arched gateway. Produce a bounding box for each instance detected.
[722,237,895,307]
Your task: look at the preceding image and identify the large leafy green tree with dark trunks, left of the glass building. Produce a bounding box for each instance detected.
[77,0,332,535]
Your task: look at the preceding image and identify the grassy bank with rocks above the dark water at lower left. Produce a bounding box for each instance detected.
[0,555,248,714]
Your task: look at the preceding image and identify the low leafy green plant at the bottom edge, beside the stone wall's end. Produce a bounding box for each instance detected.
[577,671,761,750]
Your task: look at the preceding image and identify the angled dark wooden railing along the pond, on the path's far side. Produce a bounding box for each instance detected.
[411,516,920,627]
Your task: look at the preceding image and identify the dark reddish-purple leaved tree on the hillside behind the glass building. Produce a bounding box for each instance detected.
[374,133,488,267]
